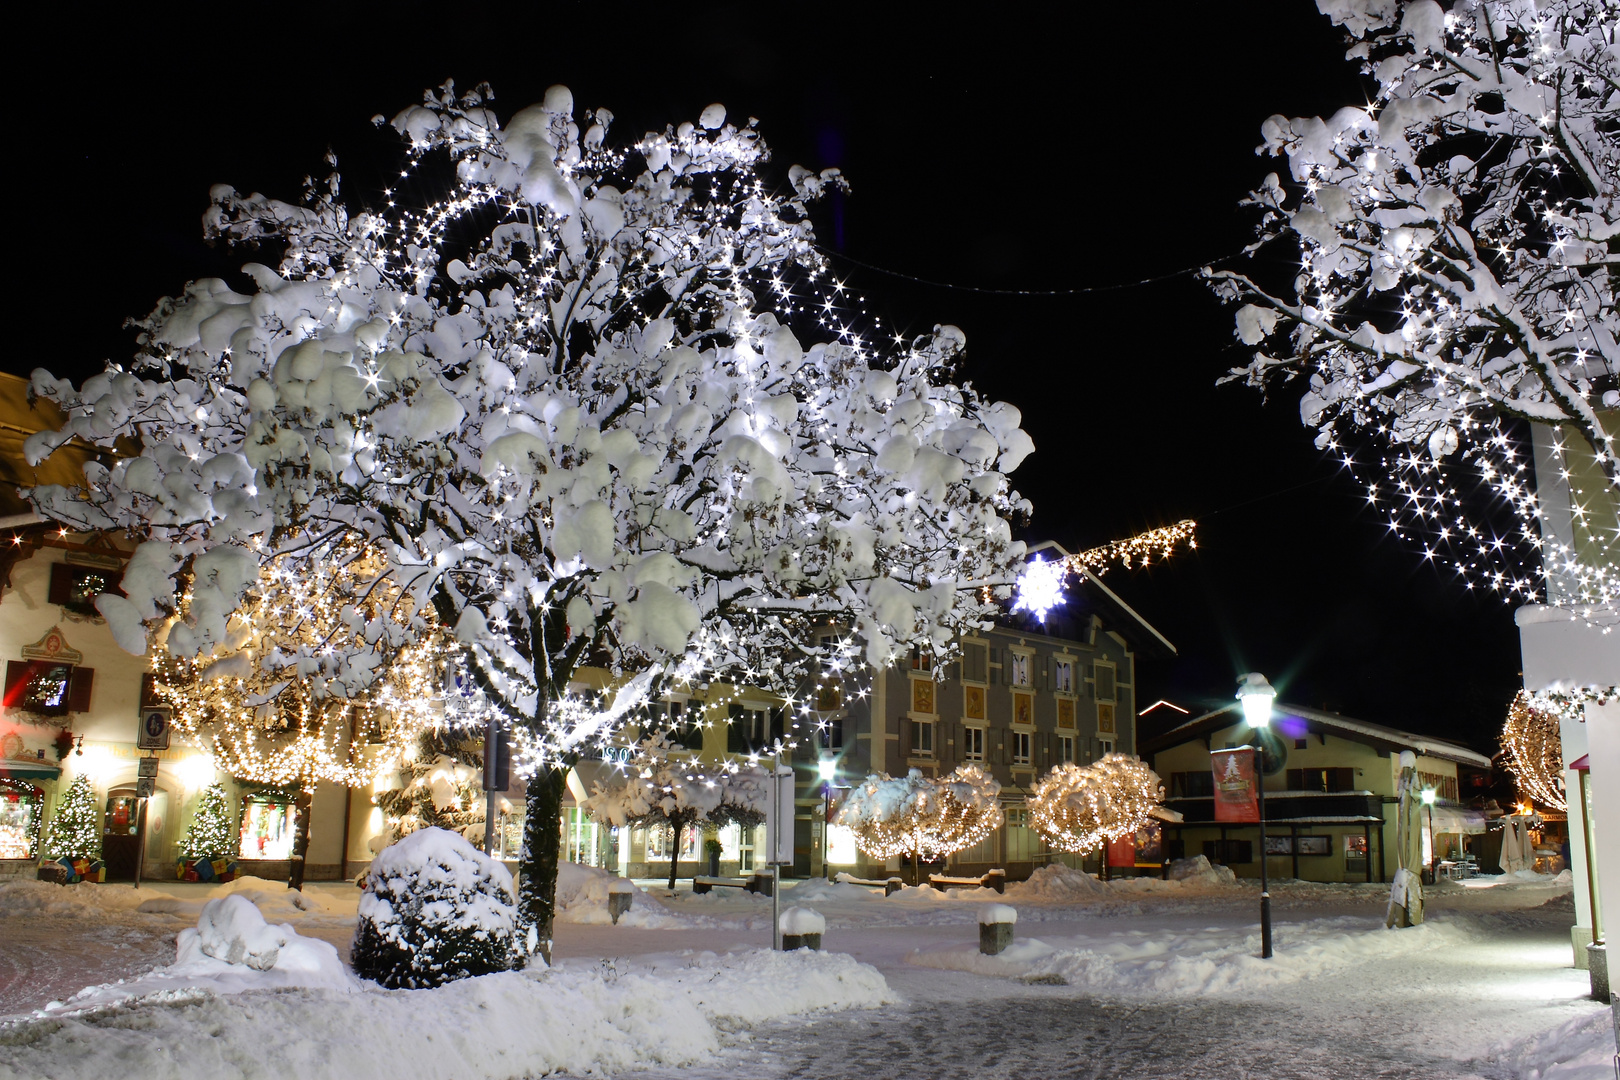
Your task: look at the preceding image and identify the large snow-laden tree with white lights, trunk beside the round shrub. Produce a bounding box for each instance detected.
[29,86,1032,952]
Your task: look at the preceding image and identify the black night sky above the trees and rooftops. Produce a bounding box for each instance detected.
[5,0,1518,751]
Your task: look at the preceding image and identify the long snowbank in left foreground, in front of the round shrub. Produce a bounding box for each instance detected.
[0,950,894,1080]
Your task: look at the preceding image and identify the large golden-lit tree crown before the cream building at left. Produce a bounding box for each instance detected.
[154,546,450,787]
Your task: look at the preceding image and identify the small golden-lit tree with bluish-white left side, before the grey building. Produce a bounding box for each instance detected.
[834,764,1006,884]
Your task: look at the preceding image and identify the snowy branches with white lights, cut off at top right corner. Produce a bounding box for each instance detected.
[1205,0,1620,599]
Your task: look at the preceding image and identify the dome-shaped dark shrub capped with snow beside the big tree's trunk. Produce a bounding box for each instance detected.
[350,829,523,988]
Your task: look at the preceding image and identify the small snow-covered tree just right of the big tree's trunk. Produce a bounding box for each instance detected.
[582,732,768,889]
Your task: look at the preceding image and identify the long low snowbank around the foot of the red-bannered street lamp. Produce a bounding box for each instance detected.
[907,916,1469,997]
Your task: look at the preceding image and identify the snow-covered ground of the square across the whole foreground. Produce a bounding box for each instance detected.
[0,868,1614,1080]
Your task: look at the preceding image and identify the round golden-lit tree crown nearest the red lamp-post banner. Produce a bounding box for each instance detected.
[1027,755,1165,855]
